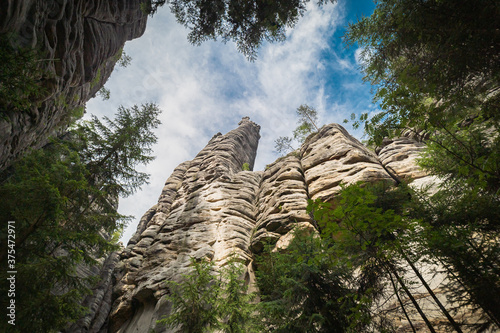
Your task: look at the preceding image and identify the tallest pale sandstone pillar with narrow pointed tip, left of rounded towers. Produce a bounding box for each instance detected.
[109,118,261,333]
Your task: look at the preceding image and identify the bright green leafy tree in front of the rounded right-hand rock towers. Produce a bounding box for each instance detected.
[308,182,430,332]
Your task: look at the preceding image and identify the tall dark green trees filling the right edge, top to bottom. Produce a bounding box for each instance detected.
[338,0,500,330]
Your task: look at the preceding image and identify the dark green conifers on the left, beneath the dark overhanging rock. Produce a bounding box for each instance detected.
[0,104,160,332]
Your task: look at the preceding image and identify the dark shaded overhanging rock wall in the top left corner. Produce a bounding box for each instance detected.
[0,0,147,170]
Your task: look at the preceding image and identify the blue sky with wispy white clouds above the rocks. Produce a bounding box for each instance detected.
[86,0,376,243]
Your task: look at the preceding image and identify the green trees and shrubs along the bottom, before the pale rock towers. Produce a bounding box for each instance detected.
[161,182,498,332]
